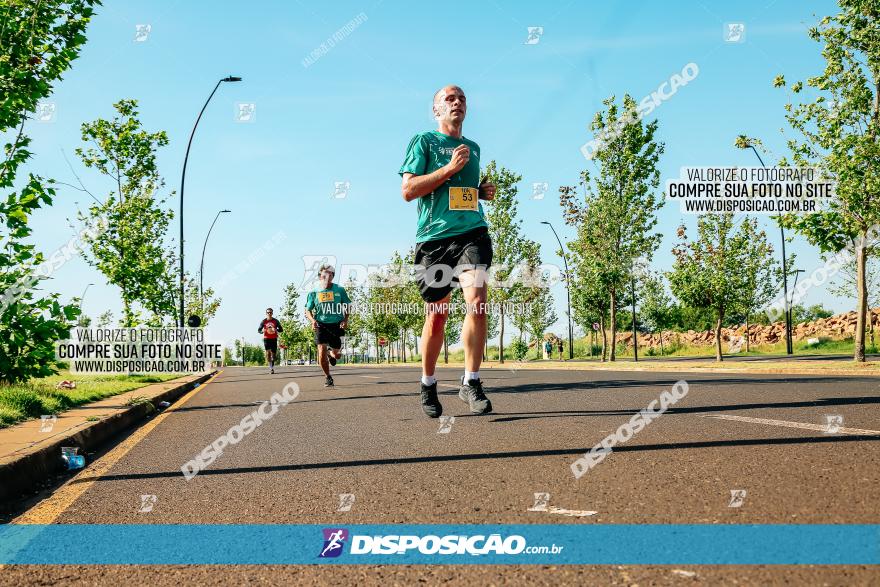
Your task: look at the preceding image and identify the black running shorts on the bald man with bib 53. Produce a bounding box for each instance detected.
[415,226,492,303]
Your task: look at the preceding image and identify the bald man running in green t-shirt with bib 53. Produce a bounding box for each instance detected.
[399,86,495,418]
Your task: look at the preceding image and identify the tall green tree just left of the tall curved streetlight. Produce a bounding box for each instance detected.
[76,100,177,327]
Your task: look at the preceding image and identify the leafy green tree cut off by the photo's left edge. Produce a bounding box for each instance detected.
[0,0,98,383]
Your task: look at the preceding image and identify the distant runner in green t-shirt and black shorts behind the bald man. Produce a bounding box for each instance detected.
[306,265,351,387]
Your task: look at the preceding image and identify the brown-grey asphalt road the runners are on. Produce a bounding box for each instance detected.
[0,366,880,585]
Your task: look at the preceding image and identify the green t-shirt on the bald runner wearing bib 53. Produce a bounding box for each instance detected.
[399,130,487,243]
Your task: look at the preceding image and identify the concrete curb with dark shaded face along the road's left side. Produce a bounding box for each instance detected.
[0,370,217,504]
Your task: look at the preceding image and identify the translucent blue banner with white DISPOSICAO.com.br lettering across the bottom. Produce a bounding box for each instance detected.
[0,524,880,565]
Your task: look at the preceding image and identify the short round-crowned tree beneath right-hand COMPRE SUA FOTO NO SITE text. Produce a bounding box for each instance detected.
[667,214,773,361]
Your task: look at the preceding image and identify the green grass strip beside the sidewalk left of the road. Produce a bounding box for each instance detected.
[0,371,181,428]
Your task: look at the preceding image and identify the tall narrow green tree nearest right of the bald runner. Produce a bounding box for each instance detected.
[559,94,665,361]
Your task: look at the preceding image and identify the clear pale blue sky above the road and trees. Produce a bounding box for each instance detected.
[22,0,852,343]
